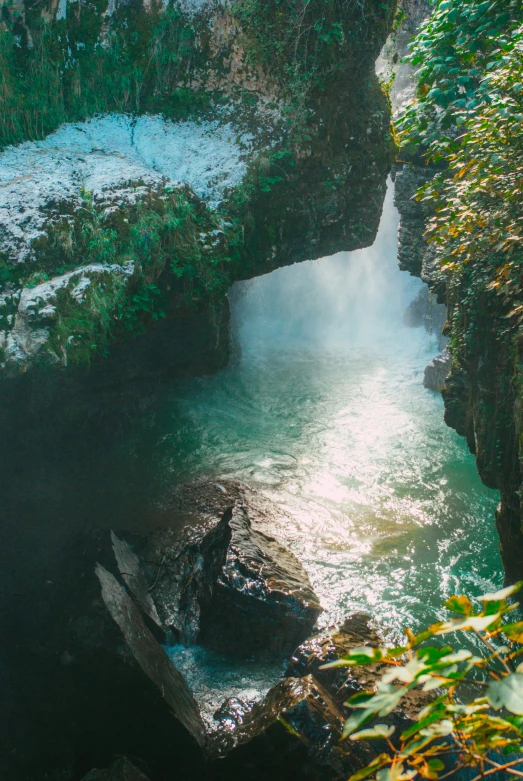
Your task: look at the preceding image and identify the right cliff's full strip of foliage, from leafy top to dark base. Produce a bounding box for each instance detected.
[398,0,523,580]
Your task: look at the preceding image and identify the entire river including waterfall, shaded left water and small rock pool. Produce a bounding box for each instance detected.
[3,180,503,716]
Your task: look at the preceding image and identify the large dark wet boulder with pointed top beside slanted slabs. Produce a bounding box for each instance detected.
[129,500,321,655]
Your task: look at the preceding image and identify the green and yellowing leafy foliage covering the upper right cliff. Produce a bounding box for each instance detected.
[398,0,523,363]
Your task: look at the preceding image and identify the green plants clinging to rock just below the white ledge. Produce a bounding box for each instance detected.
[37,187,240,364]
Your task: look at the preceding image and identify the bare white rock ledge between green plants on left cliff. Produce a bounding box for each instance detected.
[0,114,251,261]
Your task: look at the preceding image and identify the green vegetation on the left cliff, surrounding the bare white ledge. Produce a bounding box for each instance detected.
[0,0,395,372]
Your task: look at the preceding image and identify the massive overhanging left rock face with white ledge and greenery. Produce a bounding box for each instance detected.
[0,0,395,414]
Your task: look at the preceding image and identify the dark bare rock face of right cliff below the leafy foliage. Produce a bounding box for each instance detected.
[396,164,523,582]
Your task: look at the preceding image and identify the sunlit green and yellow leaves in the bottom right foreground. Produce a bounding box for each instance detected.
[324,582,523,781]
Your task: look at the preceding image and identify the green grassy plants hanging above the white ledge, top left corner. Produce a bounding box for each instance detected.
[0,0,209,147]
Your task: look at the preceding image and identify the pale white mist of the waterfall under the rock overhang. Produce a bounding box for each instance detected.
[231,186,423,354]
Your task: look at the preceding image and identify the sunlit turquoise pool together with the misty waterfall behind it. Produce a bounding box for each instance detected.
[149,186,502,634]
